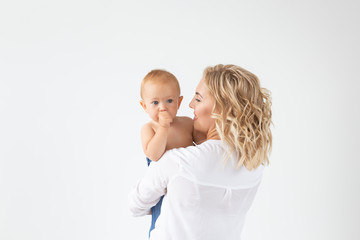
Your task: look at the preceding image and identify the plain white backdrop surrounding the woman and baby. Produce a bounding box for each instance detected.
[0,0,360,240]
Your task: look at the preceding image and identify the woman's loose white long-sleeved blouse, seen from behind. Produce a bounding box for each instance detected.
[129,140,264,240]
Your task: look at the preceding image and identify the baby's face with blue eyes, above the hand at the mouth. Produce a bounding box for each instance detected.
[142,83,181,122]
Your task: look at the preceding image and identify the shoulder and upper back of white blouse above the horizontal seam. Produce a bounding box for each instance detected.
[169,140,263,188]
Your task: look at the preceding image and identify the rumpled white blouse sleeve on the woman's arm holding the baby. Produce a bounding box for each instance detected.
[128,151,178,217]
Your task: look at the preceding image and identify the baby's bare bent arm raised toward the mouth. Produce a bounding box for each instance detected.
[141,123,168,161]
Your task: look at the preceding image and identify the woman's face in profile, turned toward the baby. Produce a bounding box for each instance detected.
[189,79,215,134]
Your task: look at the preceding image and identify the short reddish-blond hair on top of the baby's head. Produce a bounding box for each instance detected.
[140,69,180,98]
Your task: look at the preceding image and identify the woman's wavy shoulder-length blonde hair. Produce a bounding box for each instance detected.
[203,64,272,170]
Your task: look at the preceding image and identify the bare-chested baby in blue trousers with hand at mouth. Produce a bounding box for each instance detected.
[140,70,193,234]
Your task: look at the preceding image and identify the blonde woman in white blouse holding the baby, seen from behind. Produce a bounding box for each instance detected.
[129,65,272,240]
